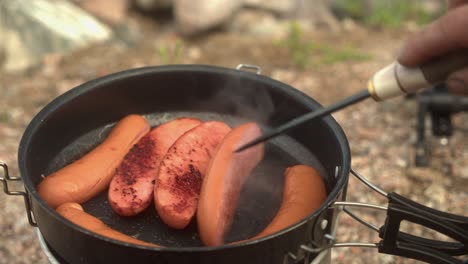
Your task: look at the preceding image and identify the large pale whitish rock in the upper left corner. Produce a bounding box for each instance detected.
[0,0,112,71]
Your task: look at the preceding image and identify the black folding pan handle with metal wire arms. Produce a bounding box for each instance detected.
[333,170,468,264]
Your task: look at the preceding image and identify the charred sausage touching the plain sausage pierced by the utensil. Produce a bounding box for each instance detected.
[154,121,231,229]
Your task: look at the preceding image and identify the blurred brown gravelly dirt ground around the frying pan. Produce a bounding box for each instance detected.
[0,11,468,264]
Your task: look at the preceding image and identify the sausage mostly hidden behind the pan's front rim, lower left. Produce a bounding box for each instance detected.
[56,203,160,247]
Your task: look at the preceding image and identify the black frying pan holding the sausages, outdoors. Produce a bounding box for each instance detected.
[0,65,468,263]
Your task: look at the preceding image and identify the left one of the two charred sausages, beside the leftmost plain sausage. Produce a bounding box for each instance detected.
[108,117,201,216]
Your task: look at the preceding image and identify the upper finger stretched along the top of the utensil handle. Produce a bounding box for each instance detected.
[398,5,468,67]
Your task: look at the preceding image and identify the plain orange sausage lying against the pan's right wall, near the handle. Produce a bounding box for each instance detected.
[236,165,327,243]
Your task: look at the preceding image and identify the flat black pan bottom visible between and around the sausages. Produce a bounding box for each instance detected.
[50,112,326,247]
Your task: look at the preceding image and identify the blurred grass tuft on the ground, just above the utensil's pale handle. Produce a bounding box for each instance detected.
[277,21,371,70]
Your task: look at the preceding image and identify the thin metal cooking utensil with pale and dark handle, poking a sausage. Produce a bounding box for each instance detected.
[236,50,468,152]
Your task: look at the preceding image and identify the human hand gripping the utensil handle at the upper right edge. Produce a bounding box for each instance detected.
[398,0,468,95]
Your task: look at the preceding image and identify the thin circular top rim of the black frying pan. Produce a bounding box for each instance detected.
[18,64,351,252]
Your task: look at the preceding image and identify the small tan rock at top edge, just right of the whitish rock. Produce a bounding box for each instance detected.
[76,0,128,25]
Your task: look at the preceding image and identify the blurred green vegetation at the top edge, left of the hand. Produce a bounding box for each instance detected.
[334,0,444,27]
